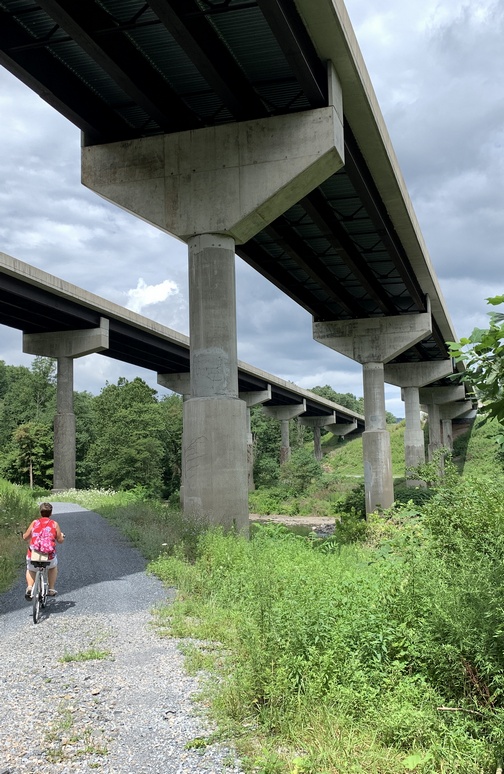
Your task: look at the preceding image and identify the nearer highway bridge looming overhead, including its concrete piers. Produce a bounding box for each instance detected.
[0,0,461,529]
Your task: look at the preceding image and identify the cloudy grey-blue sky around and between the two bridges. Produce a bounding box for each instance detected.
[0,0,504,416]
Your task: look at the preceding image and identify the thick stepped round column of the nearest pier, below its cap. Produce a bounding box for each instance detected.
[184,234,248,532]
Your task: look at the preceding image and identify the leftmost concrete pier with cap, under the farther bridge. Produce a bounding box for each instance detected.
[23,317,109,492]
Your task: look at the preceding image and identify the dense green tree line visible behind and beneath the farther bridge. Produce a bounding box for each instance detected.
[0,357,396,498]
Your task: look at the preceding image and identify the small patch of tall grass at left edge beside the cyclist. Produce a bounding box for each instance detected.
[0,479,37,593]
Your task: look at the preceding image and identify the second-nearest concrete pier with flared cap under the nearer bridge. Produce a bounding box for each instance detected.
[313,308,432,514]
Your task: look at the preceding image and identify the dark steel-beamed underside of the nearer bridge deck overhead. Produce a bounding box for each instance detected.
[0,0,447,361]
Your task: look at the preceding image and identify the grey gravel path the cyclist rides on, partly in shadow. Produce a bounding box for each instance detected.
[0,503,242,774]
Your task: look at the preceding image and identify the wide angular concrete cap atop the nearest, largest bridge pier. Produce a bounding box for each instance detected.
[82,106,344,244]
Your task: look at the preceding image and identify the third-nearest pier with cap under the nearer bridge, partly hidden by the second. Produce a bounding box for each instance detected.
[385,360,453,486]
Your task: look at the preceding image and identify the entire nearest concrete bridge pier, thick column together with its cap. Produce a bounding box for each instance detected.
[82,67,344,532]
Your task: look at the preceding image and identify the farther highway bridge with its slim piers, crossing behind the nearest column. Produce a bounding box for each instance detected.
[0,252,365,490]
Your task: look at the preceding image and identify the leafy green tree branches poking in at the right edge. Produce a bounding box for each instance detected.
[447,295,504,446]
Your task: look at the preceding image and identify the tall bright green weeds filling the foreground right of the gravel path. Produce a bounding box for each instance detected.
[151,481,504,774]
